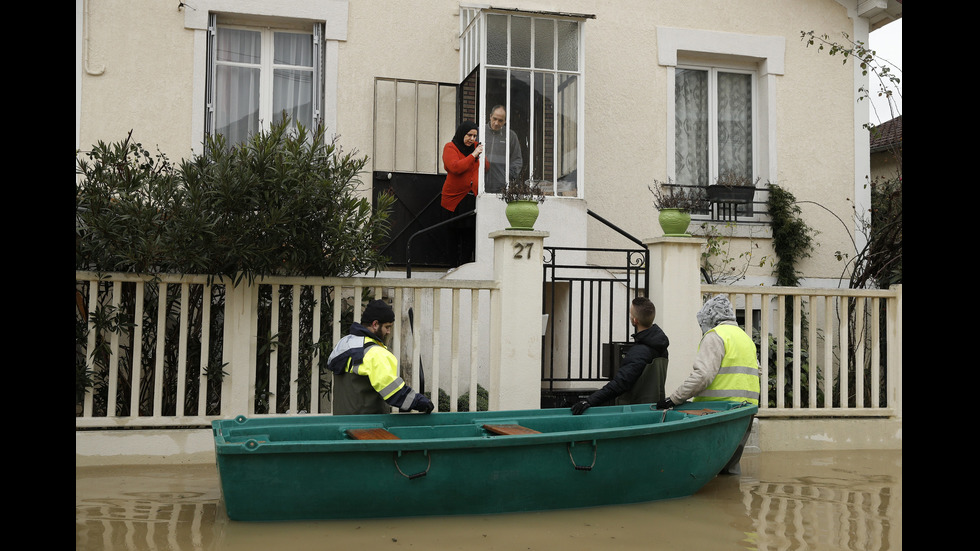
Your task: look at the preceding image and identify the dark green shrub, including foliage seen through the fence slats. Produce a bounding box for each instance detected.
[75,117,393,415]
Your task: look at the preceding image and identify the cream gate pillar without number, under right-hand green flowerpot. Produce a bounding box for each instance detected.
[644,237,707,396]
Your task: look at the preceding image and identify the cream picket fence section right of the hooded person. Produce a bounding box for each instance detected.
[702,285,902,417]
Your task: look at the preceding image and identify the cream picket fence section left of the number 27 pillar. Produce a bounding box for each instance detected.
[75,272,497,428]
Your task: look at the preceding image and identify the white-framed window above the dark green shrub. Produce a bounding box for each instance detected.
[206,16,322,144]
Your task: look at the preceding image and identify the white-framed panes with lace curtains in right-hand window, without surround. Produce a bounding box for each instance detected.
[674,67,755,190]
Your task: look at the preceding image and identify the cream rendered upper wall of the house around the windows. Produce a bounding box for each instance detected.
[76,0,867,284]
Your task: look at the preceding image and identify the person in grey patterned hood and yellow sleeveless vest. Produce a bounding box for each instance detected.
[657,295,760,474]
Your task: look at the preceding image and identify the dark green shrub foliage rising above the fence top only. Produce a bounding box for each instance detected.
[75,117,393,282]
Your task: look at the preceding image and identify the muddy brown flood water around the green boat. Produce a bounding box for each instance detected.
[75,450,902,551]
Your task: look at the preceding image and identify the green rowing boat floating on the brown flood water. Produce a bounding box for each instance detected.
[213,402,757,521]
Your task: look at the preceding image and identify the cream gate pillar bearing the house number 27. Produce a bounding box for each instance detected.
[488,230,548,411]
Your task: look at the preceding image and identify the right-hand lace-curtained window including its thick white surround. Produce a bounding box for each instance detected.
[657,27,786,222]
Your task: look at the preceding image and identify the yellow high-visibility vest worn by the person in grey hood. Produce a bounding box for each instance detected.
[692,325,760,405]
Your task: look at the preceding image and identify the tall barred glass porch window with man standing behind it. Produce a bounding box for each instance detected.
[460,10,582,196]
